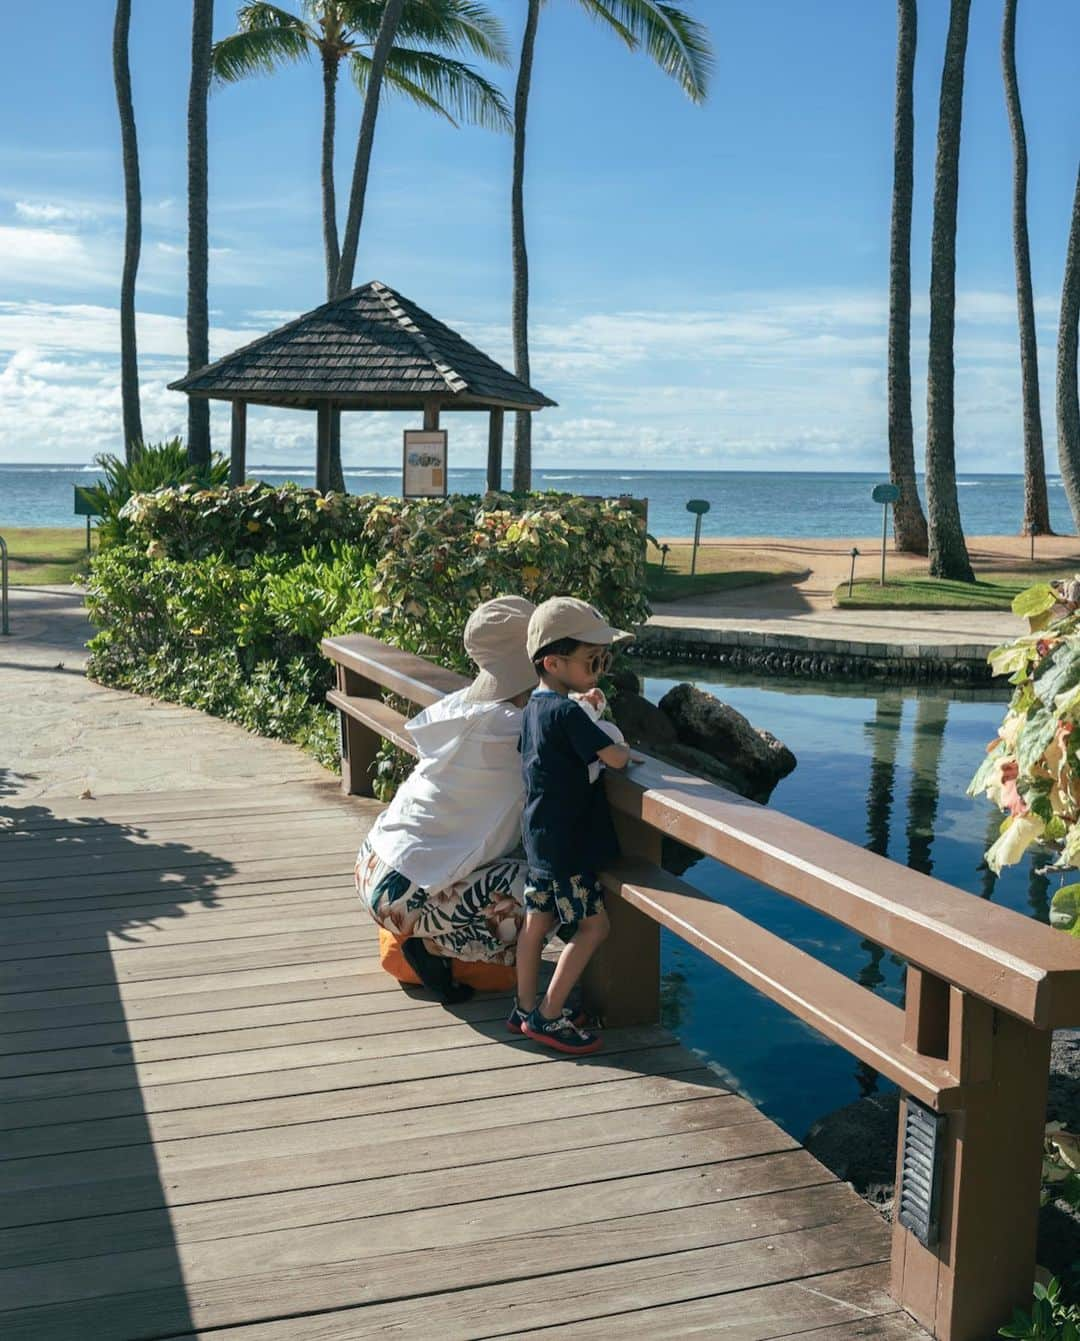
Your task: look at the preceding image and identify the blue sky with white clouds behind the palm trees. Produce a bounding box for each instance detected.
[0,0,1080,473]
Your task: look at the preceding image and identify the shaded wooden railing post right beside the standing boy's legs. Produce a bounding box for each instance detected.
[581,810,663,1027]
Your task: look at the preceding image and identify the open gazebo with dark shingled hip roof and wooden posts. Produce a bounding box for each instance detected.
[169,280,555,491]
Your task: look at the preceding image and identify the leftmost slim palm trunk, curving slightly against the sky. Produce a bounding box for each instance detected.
[113,0,142,465]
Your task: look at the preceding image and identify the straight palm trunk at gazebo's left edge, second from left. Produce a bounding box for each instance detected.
[188,0,213,469]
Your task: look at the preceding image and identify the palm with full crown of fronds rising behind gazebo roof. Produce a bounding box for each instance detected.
[213,0,510,491]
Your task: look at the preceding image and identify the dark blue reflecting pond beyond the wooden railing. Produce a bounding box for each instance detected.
[639,665,1035,1140]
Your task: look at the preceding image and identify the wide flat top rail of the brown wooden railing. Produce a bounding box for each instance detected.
[322,634,1080,1029]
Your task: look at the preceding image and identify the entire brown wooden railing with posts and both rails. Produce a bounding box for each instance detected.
[322,636,1080,1341]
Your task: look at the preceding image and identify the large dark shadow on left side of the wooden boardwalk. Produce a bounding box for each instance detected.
[0,770,235,1337]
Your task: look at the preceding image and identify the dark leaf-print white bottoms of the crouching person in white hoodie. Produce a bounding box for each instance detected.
[354,841,525,964]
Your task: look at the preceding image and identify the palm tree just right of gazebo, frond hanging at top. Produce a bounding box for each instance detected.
[510,0,712,489]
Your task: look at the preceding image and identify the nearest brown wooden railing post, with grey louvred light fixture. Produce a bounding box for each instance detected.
[892,966,1050,1341]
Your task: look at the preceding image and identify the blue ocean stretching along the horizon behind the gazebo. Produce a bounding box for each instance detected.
[0,464,1075,539]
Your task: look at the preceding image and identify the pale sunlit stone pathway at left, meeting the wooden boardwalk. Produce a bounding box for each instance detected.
[0,586,330,801]
